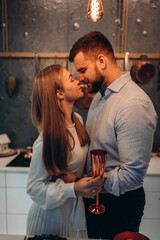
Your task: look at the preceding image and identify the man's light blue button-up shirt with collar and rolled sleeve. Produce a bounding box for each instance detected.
[86,72,157,196]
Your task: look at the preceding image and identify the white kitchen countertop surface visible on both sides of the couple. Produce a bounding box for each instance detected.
[0,152,160,175]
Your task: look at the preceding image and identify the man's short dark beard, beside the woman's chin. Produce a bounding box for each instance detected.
[88,66,104,93]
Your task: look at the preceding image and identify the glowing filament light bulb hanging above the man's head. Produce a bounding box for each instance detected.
[87,0,103,22]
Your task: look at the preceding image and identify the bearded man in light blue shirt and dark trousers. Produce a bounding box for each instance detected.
[69,32,157,239]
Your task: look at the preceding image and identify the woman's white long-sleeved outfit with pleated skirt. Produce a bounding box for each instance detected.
[26,116,88,238]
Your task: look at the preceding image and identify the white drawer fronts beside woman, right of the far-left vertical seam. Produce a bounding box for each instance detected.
[6,172,32,235]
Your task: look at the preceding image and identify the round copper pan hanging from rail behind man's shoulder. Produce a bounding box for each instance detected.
[131,55,155,83]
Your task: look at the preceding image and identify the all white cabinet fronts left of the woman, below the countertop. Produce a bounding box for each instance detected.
[0,169,32,235]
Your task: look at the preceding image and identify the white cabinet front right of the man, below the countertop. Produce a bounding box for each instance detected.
[140,175,160,240]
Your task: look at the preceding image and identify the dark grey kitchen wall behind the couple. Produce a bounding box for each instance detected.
[0,0,160,151]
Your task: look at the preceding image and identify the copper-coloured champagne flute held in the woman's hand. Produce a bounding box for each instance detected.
[88,149,107,214]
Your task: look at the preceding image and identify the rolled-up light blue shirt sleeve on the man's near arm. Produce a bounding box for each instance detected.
[104,100,157,196]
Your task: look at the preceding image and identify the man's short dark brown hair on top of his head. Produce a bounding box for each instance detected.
[69,31,114,62]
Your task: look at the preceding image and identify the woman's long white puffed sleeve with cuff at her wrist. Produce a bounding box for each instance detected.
[27,137,76,210]
